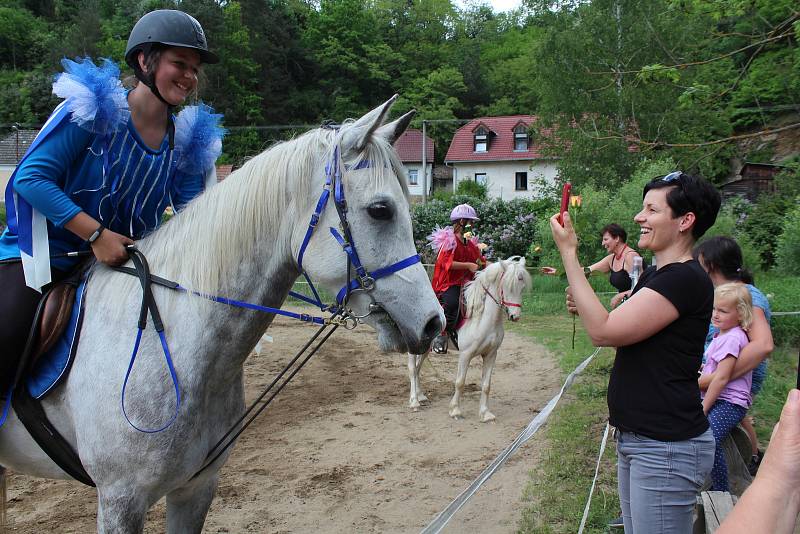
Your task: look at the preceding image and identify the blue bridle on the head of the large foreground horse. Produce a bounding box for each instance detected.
[292,142,420,320]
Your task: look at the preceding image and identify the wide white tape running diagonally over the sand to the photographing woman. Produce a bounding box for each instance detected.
[422,347,601,534]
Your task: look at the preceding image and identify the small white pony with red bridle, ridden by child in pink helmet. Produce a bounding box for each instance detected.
[408,257,531,423]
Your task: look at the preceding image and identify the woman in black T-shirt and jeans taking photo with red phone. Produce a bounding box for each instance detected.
[550,172,721,534]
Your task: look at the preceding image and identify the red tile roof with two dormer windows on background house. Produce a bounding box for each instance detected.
[444,115,553,161]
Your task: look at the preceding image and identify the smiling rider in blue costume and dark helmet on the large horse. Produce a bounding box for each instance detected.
[0,10,222,402]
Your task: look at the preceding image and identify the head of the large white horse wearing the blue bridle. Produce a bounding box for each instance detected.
[292,96,444,353]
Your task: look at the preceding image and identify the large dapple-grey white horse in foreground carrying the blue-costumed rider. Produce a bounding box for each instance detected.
[0,96,444,534]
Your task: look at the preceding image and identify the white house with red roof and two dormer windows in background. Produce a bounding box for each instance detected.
[444,115,558,200]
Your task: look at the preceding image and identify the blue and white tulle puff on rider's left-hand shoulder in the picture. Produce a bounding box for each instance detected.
[53,58,130,134]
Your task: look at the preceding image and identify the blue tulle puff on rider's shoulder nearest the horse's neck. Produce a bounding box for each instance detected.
[175,104,225,174]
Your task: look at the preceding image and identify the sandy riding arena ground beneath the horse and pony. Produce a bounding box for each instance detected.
[3,319,559,533]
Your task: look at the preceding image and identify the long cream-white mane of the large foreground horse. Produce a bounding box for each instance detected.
[90,121,408,314]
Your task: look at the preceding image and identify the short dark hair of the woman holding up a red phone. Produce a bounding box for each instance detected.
[642,172,722,239]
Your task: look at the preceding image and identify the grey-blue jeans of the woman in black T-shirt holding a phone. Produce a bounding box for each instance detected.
[617,429,714,534]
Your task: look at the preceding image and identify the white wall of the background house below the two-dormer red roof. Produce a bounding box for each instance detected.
[451,160,558,200]
